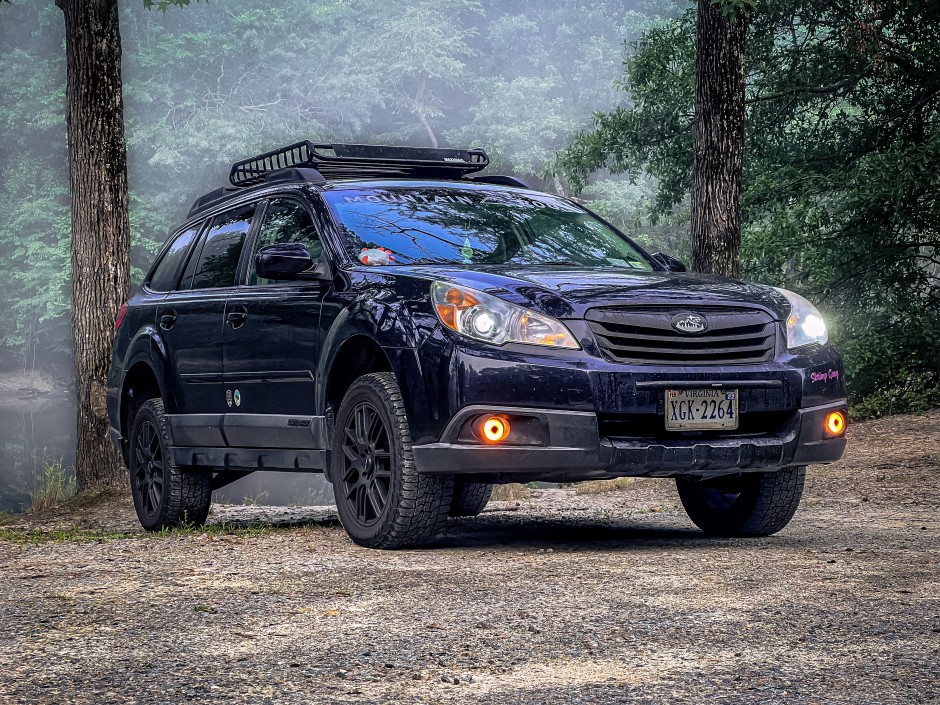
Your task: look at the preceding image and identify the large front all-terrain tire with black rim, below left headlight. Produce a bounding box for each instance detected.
[330,372,454,549]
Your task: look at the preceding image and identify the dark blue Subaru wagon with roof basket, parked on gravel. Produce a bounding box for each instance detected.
[108,142,846,548]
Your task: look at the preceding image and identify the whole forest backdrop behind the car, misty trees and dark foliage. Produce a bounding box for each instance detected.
[0,0,940,506]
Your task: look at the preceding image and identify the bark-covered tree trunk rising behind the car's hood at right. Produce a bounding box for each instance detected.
[692,0,747,277]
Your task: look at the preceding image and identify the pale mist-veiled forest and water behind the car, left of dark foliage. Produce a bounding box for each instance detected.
[0,0,684,511]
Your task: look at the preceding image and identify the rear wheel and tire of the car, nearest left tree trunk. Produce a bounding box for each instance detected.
[128,399,212,531]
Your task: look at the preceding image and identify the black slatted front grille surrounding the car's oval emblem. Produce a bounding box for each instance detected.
[585,306,778,365]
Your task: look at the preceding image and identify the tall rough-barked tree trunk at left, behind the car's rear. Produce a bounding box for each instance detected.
[56,0,130,492]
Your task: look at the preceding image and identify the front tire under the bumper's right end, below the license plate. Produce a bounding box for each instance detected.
[676,466,806,537]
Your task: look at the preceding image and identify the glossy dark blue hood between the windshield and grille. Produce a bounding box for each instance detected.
[386,265,790,319]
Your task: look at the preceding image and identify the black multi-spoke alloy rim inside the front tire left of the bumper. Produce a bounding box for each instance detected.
[342,401,392,526]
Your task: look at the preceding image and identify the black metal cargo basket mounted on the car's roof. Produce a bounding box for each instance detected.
[229,141,490,186]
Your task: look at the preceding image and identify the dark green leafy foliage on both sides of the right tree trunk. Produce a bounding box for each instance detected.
[559,0,940,414]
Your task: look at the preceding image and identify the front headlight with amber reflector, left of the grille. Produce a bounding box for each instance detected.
[431,282,581,350]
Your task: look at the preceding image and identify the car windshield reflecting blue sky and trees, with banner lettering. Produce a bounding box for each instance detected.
[323,185,653,271]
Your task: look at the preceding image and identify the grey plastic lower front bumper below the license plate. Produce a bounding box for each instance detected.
[413,401,846,482]
